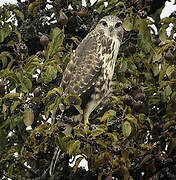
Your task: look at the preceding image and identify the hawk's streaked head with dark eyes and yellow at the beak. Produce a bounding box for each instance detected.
[95,16,124,42]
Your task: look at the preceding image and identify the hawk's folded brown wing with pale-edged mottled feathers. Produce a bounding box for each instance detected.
[61,32,102,96]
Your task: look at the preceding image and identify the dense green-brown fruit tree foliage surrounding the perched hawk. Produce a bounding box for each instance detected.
[0,0,176,180]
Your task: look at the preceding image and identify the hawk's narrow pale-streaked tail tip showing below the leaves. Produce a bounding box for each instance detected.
[49,146,61,176]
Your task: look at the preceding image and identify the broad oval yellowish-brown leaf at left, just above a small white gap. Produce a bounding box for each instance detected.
[23,108,34,127]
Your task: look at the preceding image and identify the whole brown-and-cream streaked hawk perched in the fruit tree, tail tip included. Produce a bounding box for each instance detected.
[50,15,124,174]
